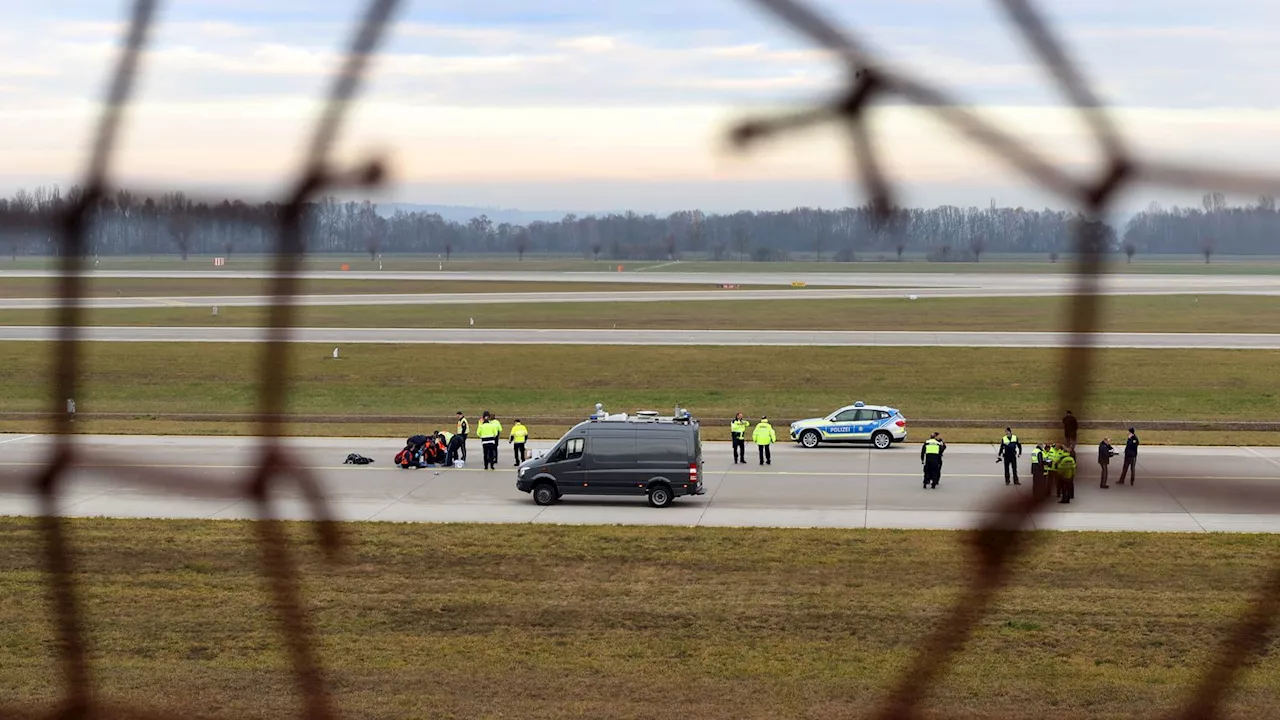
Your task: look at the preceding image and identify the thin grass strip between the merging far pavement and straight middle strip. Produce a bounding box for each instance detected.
[0,291,1280,333]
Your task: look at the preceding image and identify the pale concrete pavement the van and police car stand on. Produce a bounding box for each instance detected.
[0,428,1280,533]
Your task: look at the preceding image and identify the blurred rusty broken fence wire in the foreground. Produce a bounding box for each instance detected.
[0,0,1280,719]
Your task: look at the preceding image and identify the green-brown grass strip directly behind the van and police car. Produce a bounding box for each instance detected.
[0,342,1280,437]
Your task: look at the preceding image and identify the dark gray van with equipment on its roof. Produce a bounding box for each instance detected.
[516,414,707,507]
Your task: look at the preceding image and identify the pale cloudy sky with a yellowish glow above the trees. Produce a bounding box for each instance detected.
[0,0,1280,213]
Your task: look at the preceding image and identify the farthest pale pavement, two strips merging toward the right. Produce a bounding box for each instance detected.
[0,270,1280,310]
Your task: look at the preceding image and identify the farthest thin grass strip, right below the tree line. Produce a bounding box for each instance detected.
[10,252,1280,275]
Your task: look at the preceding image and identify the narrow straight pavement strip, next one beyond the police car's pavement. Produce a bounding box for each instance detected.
[0,325,1280,350]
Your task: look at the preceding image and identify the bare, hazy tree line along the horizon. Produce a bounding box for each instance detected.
[0,187,1280,261]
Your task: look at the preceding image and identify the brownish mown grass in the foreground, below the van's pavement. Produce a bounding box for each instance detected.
[0,519,1280,720]
